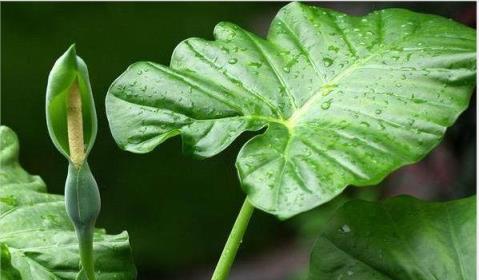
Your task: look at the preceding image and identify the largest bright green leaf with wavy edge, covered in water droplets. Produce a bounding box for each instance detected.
[106,3,476,218]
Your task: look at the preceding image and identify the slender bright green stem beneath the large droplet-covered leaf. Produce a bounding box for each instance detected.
[211,199,254,280]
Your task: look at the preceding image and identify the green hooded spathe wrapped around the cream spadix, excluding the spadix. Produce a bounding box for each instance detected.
[46,45,97,159]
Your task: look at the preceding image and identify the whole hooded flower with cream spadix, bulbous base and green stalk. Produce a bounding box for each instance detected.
[46,46,101,280]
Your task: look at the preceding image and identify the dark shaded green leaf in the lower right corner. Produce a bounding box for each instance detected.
[309,196,476,280]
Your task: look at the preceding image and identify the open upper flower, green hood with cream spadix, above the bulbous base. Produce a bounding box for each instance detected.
[46,45,97,166]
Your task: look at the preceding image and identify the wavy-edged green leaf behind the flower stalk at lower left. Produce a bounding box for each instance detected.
[0,126,136,280]
